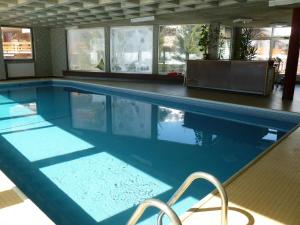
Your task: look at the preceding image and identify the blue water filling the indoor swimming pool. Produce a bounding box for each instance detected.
[0,82,300,225]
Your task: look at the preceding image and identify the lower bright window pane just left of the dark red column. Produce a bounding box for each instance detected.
[272,39,289,73]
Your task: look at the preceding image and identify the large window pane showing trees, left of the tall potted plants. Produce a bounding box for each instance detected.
[158,24,203,74]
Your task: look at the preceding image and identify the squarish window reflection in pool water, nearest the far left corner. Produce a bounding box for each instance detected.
[71,92,107,132]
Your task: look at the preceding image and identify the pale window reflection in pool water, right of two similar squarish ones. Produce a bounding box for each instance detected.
[112,96,151,138]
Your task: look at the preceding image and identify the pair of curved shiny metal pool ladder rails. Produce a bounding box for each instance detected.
[127,172,228,225]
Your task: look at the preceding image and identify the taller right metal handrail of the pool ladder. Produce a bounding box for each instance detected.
[157,172,228,225]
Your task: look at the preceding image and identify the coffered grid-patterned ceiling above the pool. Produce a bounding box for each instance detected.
[0,0,298,27]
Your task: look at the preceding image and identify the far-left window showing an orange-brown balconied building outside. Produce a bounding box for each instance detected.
[1,27,33,59]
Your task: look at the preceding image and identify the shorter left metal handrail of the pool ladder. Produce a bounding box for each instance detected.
[127,198,182,225]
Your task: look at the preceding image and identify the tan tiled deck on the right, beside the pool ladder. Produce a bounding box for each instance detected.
[183,128,300,225]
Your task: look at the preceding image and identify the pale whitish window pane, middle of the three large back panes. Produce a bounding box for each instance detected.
[111,26,153,73]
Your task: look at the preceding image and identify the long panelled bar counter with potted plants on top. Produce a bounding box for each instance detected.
[186,60,274,95]
